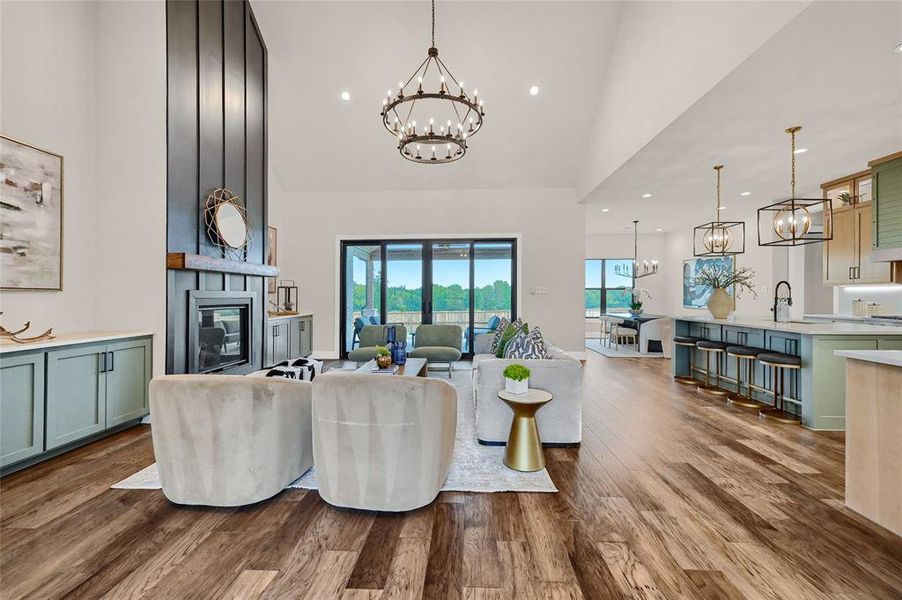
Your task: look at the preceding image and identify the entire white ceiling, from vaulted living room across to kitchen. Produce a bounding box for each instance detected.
[253,0,902,227]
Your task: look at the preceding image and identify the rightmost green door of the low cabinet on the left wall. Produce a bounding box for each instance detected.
[106,339,153,427]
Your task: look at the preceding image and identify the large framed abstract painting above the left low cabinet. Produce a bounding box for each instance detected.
[0,136,63,290]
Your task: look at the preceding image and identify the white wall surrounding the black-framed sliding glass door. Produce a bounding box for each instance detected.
[270,188,585,356]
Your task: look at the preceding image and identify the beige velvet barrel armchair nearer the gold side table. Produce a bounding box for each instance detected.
[313,373,457,511]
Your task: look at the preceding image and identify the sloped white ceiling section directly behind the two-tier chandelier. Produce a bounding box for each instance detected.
[253,0,620,192]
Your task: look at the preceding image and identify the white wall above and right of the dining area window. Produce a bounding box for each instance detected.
[586,233,671,314]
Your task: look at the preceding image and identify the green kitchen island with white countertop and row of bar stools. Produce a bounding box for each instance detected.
[671,315,902,431]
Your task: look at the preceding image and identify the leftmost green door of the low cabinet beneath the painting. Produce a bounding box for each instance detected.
[0,352,44,467]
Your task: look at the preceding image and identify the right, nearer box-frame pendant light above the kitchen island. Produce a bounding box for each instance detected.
[758,126,833,246]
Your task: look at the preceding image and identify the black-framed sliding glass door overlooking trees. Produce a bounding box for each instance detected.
[341,239,517,356]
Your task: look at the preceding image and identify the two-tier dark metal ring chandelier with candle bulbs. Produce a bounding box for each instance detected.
[381,0,485,164]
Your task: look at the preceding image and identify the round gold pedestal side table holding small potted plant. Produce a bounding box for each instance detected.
[498,390,553,471]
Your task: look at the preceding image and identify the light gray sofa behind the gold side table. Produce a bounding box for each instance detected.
[473,334,583,446]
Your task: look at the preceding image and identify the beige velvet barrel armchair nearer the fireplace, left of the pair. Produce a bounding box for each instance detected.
[150,375,313,506]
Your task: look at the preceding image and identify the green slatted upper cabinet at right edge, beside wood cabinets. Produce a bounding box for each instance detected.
[870,152,902,260]
